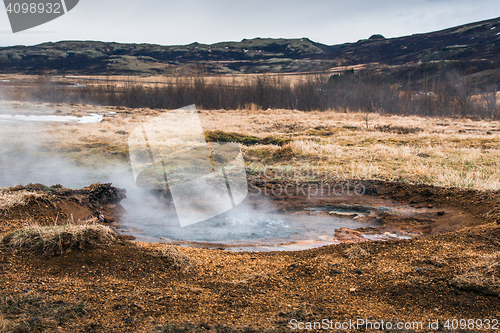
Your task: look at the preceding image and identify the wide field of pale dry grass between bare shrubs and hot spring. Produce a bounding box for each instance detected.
[3,98,500,190]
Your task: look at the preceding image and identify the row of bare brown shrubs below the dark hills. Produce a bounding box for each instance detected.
[1,71,500,119]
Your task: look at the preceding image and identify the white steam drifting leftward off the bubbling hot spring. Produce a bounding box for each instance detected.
[0,100,290,242]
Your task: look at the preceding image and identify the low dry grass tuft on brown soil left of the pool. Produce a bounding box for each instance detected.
[0,221,116,256]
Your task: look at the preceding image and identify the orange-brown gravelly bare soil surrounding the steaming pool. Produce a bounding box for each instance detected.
[0,180,500,332]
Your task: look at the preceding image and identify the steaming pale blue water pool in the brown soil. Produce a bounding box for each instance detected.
[119,201,386,251]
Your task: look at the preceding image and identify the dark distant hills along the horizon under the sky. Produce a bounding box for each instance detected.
[0,18,500,79]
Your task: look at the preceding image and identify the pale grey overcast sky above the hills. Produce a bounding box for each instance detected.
[0,0,500,46]
